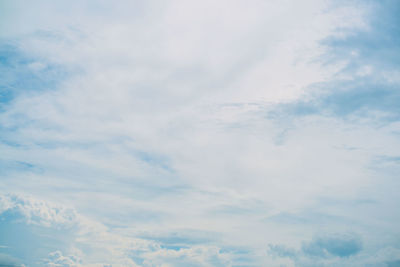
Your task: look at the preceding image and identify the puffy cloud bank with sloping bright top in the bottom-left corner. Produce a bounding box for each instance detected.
[0,196,231,267]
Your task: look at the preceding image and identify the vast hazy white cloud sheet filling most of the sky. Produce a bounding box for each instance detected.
[0,0,399,266]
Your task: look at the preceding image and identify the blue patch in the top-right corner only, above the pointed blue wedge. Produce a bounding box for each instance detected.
[321,0,400,69]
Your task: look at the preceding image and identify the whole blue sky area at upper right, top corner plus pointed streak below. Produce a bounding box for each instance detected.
[270,0,400,123]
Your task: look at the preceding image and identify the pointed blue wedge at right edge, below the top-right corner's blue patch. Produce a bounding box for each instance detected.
[271,78,400,122]
